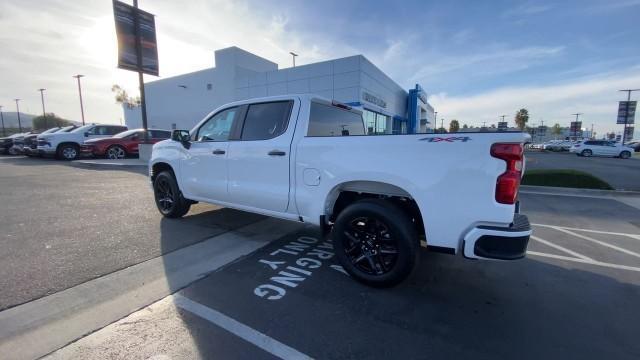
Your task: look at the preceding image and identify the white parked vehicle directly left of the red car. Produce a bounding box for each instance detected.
[38,124,127,160]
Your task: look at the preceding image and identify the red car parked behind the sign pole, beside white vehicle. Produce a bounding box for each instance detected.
[80,129,171,159]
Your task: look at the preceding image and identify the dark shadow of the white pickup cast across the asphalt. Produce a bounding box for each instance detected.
[162,217,640,359]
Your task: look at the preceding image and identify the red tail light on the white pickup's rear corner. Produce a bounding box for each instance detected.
[491,143,523,205]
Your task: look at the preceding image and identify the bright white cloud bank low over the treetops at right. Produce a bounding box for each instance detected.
[429,66,640,134]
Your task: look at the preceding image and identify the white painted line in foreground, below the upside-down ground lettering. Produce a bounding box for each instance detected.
[173,294,311,359]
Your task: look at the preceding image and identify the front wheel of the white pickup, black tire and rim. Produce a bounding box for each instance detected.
[153,171,191,218]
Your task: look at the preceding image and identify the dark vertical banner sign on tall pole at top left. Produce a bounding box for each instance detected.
[113,0,159,76]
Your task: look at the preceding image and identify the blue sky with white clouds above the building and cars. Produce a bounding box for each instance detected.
[0,0,640,133]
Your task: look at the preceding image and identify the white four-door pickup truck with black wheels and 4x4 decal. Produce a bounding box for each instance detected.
[149,95,531,286]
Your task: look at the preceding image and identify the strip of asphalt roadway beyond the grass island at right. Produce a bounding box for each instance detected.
[526,151,640,191]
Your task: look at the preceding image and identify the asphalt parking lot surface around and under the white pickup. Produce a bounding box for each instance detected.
[0,158,640,359]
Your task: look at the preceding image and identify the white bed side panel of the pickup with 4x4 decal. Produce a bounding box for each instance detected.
[295,133,526,250]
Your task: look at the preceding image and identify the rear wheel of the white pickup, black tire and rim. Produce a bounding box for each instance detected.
[331,199,420,287]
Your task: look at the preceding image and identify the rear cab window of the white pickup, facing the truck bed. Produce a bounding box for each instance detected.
[307,102,365,136]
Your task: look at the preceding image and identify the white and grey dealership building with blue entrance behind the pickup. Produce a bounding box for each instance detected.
[124,47,434,134]
